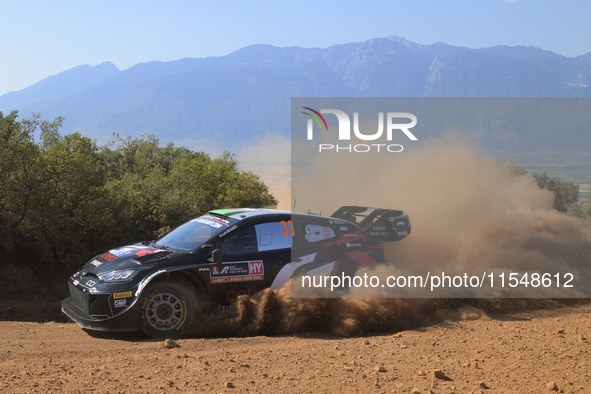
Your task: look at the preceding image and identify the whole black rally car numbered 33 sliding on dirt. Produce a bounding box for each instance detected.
[62,206,410,337]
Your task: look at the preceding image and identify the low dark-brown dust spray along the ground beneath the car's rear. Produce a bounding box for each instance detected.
[186,282,572,337]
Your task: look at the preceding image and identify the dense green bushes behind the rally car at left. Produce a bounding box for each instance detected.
[0,111,277,273]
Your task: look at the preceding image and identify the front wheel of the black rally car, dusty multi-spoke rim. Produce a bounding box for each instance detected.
[138,282,204,338]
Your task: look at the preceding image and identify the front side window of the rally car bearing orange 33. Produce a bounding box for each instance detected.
[221,222,294,255]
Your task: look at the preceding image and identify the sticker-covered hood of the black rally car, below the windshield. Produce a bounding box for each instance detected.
[83,243,172,275]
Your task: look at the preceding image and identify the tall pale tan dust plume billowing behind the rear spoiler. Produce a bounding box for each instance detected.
[293,134,591,297]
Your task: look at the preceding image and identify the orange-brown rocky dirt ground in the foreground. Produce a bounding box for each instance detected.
[0,303,591,394]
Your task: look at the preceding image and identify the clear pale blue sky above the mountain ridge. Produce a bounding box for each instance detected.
[0,0,591,95]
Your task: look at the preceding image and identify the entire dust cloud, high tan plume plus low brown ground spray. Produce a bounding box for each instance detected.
[209,135,591,336]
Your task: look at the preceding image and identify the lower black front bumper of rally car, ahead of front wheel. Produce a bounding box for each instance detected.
[62,297,139,331]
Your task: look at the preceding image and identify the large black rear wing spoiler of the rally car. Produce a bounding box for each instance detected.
[330,206,410,242]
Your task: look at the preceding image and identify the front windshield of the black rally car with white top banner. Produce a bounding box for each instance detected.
[154,216,236,252]
